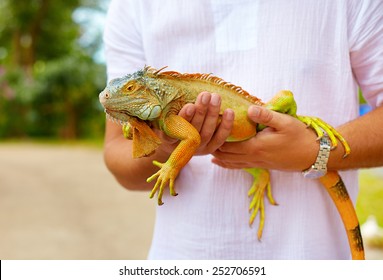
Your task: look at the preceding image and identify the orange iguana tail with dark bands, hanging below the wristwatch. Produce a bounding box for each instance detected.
[319,171,364,260]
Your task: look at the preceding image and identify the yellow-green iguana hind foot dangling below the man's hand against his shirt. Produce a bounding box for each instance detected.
[244,168,277,240]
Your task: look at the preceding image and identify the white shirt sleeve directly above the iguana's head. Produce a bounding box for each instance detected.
[103,0,145,81]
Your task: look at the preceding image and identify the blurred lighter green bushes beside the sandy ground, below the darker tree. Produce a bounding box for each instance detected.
[0,54,106,138]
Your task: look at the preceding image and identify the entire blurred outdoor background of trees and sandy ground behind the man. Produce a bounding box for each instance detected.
[0,0,383,259]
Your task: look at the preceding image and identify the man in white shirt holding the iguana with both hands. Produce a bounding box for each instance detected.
[104,0,383,259]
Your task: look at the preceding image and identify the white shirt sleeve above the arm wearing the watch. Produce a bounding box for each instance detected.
[348,0,383,108]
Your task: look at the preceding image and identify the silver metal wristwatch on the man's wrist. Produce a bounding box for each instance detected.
[302,133,331,179]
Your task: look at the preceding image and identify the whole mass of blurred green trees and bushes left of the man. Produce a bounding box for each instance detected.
[0,0,106,138]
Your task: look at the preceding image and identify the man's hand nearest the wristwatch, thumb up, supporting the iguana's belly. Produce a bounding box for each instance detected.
[213,106,319,171]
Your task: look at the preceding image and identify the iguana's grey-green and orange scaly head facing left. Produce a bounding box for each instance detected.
[99,70,161,122]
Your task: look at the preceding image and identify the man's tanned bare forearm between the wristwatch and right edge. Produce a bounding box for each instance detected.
[328,106,383,170]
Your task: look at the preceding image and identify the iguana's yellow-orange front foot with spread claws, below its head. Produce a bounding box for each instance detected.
[146,161,178,205]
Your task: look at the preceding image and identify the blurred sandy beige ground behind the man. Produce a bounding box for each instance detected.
[0,143,383,260]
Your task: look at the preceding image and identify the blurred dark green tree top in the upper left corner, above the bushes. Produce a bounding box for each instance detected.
[0,0,80,71]
